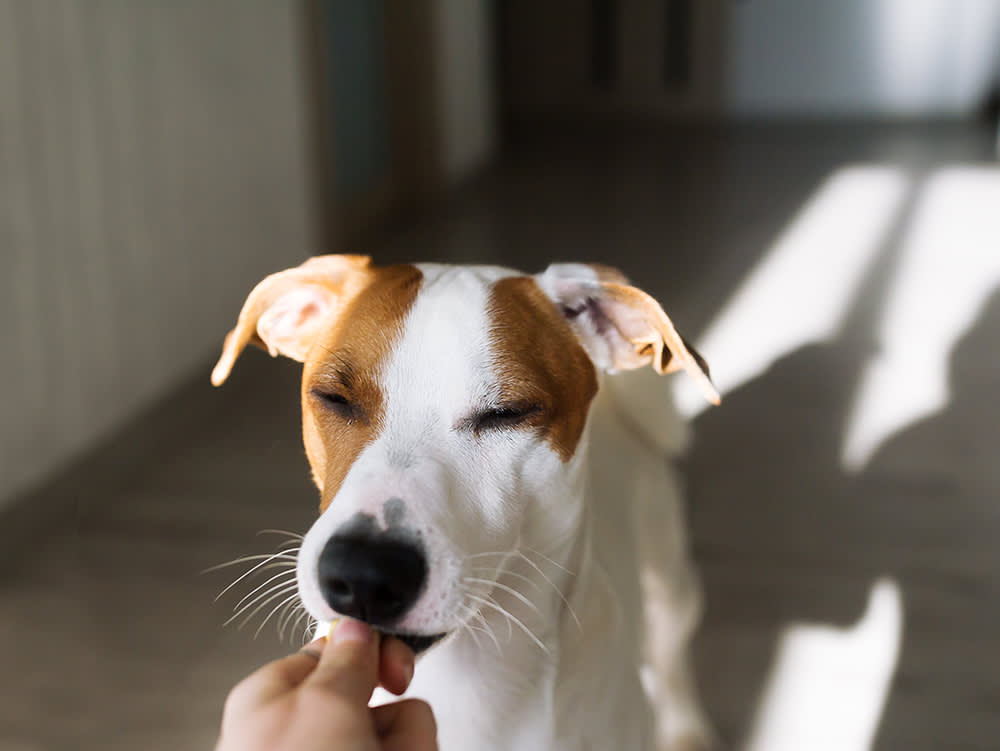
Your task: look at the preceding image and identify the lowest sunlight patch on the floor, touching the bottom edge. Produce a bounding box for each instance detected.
[746,579,903,751]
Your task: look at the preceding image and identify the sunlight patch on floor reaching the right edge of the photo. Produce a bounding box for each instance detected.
[841,167,1000,472]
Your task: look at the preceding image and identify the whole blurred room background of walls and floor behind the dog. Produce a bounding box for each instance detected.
[0,0,1000,751]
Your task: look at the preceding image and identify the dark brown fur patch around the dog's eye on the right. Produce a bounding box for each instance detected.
[488,276,597,462]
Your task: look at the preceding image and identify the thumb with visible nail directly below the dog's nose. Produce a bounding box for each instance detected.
[305,618,379,705]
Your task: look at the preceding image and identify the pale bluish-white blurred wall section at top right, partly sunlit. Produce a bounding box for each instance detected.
[725,0,1000,117]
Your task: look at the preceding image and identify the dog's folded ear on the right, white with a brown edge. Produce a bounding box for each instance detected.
[535,263,720,404]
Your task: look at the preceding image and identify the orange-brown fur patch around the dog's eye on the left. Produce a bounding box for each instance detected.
[302,265,423,512]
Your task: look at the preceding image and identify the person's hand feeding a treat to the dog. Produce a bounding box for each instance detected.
[216,619,437,751]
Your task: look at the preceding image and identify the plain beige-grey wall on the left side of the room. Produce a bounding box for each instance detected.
[0,0,313,504]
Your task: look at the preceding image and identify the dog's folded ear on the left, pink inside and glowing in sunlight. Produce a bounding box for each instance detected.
[212,255,371,386]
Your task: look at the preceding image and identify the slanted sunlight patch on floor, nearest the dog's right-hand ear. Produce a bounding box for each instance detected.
[675,165,909,417]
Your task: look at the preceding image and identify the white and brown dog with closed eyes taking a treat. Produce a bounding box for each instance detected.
[212,255,719,751]
